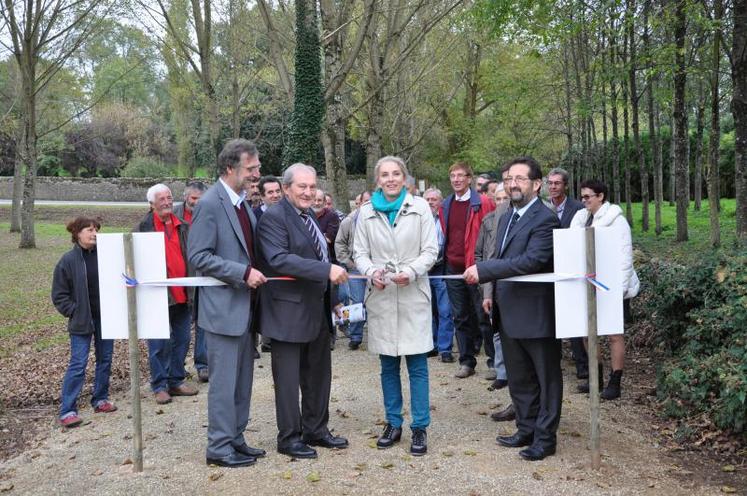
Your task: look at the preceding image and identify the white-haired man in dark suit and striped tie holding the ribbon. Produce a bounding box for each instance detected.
[257,164,348,458]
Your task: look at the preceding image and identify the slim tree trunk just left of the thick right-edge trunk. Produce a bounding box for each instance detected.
[708,0,724,248]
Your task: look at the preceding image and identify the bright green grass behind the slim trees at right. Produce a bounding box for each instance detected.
[621,199,736,263]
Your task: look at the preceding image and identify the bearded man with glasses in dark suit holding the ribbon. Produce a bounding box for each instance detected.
[464,157,563,460]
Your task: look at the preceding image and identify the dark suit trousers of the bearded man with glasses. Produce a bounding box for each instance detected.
[500,330,563,448]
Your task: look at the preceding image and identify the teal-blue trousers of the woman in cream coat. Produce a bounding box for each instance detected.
[379,353,431,429]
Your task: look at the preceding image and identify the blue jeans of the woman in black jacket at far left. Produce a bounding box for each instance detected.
[60,318,114,417]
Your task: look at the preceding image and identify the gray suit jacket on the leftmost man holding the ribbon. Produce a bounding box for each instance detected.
[187,181,257,336]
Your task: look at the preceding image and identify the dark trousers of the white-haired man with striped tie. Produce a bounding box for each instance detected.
[270,323,332,448]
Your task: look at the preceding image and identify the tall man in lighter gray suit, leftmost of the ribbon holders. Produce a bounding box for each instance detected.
[188,139,266,467]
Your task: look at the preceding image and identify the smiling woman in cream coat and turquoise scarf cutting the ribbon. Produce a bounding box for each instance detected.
[353,157,438,455]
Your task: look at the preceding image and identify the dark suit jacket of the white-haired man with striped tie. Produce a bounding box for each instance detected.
[257,198,332,343]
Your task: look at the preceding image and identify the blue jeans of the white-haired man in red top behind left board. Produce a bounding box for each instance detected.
[148,303,192,393]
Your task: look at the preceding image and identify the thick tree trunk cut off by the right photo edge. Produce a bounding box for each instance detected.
[731,0,747,245]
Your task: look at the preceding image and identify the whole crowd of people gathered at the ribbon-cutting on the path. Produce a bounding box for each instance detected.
[52,139,639,467]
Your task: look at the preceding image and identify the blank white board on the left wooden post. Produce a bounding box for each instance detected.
[96,232,170,339]
